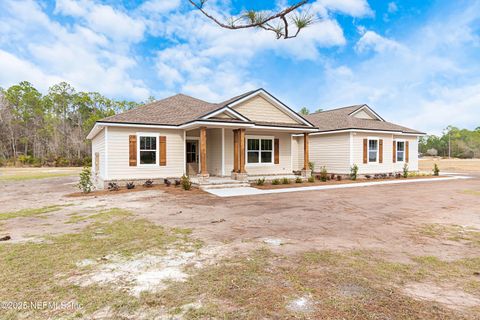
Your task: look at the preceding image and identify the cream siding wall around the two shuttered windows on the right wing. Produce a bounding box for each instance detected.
[352,132,418,174]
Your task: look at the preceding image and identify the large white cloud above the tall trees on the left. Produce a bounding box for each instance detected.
[0,1,150,100]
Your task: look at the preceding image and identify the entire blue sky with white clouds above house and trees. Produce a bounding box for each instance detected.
[0,0,480,134]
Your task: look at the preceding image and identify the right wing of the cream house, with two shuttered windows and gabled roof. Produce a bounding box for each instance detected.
[294,104,425,174]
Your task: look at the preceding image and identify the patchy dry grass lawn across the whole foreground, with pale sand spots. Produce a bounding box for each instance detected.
[0,209,480,319]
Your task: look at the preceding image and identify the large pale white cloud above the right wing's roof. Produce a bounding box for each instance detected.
[319,3,480,134]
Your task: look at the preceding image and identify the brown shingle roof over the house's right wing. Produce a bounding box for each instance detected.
[305,104,423,134]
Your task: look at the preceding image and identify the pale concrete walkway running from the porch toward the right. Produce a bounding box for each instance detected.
[205,176,470,198]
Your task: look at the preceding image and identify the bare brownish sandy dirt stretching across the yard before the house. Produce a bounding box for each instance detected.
[0,168,480,316]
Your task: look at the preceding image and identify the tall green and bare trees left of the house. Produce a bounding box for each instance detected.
[0,81,139,166]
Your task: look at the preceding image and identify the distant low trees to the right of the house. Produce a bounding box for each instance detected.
[419,126,480,158]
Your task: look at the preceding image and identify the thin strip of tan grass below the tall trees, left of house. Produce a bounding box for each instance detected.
[0,167,81,182]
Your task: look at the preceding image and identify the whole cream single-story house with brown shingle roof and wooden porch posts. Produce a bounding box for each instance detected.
[87,89,422,188]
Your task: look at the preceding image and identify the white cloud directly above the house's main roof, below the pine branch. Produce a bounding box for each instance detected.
[153,1,346,99]
